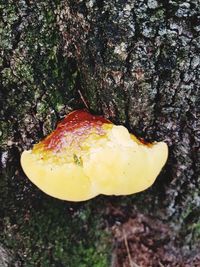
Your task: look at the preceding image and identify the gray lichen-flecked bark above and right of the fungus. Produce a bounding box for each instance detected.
[57,0,200,260]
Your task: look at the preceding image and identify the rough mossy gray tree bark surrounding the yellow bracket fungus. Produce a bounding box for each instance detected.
[0,0,200,267]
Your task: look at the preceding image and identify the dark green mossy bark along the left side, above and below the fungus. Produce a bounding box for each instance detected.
[0,1,109,267]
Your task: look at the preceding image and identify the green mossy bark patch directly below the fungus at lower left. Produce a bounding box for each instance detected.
[0,162,111,267]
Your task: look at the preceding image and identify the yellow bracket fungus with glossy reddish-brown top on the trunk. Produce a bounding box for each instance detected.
[21,110,168,201]
